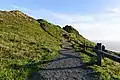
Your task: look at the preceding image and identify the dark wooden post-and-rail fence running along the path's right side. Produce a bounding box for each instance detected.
[74,41,120,66]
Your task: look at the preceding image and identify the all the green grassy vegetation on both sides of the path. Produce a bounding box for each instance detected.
[0,10,120,80]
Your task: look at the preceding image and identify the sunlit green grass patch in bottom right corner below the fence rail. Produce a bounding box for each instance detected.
[93,58,120,80]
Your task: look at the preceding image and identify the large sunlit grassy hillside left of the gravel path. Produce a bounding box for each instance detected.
[0,11,61,80]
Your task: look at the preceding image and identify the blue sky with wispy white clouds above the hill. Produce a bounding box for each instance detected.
[0,0,120,41]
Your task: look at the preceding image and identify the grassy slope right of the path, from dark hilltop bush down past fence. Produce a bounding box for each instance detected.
[63,26,120,80]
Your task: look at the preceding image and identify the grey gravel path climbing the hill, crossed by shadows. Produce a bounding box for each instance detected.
[28,39,99,80]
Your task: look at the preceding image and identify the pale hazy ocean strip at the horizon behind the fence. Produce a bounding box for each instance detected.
[94,40,120,52]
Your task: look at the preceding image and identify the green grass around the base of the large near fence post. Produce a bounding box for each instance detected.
[72,42,120,80]
